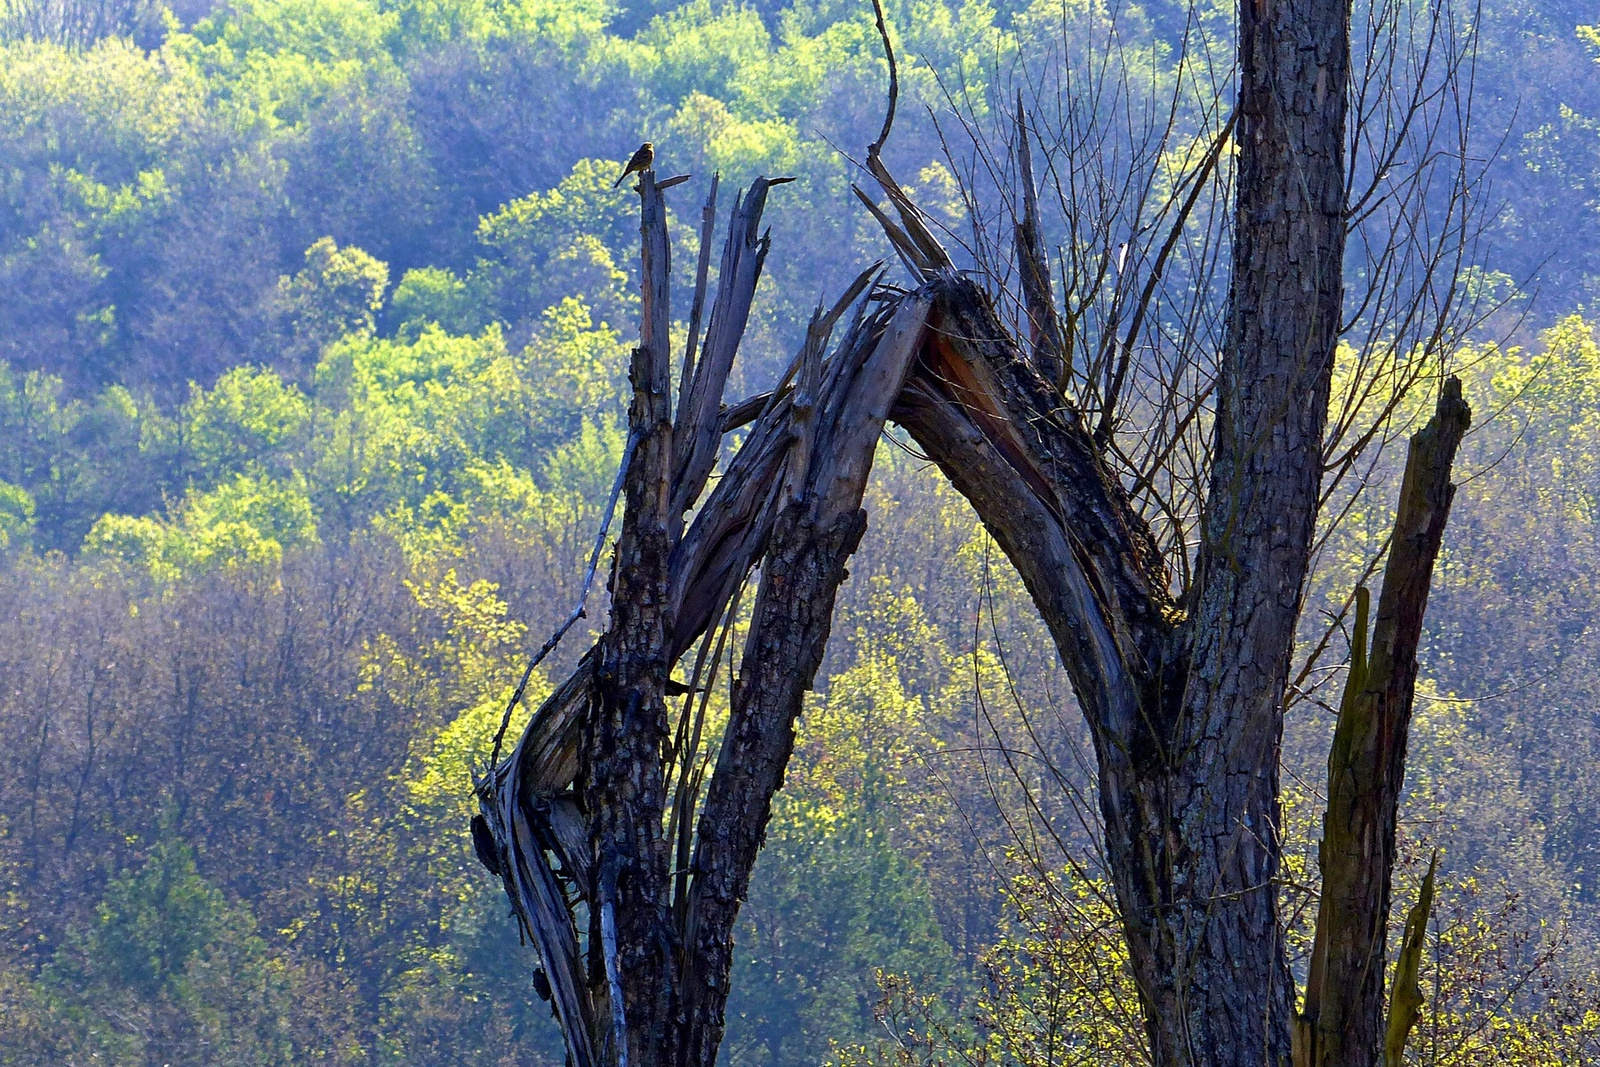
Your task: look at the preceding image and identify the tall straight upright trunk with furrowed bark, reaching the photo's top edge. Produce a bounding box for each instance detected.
[1139,0,1349,1064]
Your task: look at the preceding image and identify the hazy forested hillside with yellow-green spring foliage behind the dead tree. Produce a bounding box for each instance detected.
[0,0,1600,1067]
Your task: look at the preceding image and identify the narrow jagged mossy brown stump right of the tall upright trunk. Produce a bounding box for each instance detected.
[1294,378,1472,1067]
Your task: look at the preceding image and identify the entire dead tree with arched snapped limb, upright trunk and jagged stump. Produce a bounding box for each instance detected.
[478,0,1484,1067]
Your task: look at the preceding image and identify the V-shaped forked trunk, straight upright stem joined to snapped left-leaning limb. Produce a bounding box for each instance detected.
[899,0,1349,1065]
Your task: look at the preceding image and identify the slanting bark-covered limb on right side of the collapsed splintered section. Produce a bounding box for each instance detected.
[678,298,928,1067]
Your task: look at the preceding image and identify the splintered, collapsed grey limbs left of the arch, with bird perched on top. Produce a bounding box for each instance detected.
[478,170,926,1067]
